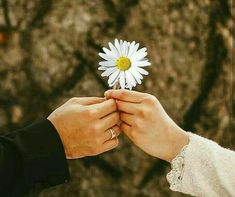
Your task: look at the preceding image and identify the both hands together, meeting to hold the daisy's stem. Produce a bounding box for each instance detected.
[48,90,188,162]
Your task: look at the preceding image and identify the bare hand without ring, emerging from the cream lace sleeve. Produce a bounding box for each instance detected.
[105,90,188,162]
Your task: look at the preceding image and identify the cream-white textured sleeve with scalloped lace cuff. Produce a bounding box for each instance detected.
[167,133,235,197]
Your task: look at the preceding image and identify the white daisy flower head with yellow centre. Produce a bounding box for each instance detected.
[98,39,151,90]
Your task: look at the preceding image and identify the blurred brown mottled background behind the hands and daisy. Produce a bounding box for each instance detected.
[0,0,235,197]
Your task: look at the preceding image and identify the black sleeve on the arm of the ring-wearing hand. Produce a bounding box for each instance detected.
[0,120,70,196]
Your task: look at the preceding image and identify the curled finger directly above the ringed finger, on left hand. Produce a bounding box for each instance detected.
[99,112,120,131]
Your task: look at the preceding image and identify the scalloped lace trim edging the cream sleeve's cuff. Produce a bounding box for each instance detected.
[166,144,188,192]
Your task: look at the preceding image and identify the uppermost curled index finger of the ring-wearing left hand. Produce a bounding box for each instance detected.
[89,99,117,118]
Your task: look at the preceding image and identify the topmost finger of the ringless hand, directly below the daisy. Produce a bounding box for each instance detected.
[104,90,146,103]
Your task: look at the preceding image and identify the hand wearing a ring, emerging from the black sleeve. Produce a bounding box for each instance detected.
[48,97,120,159]
